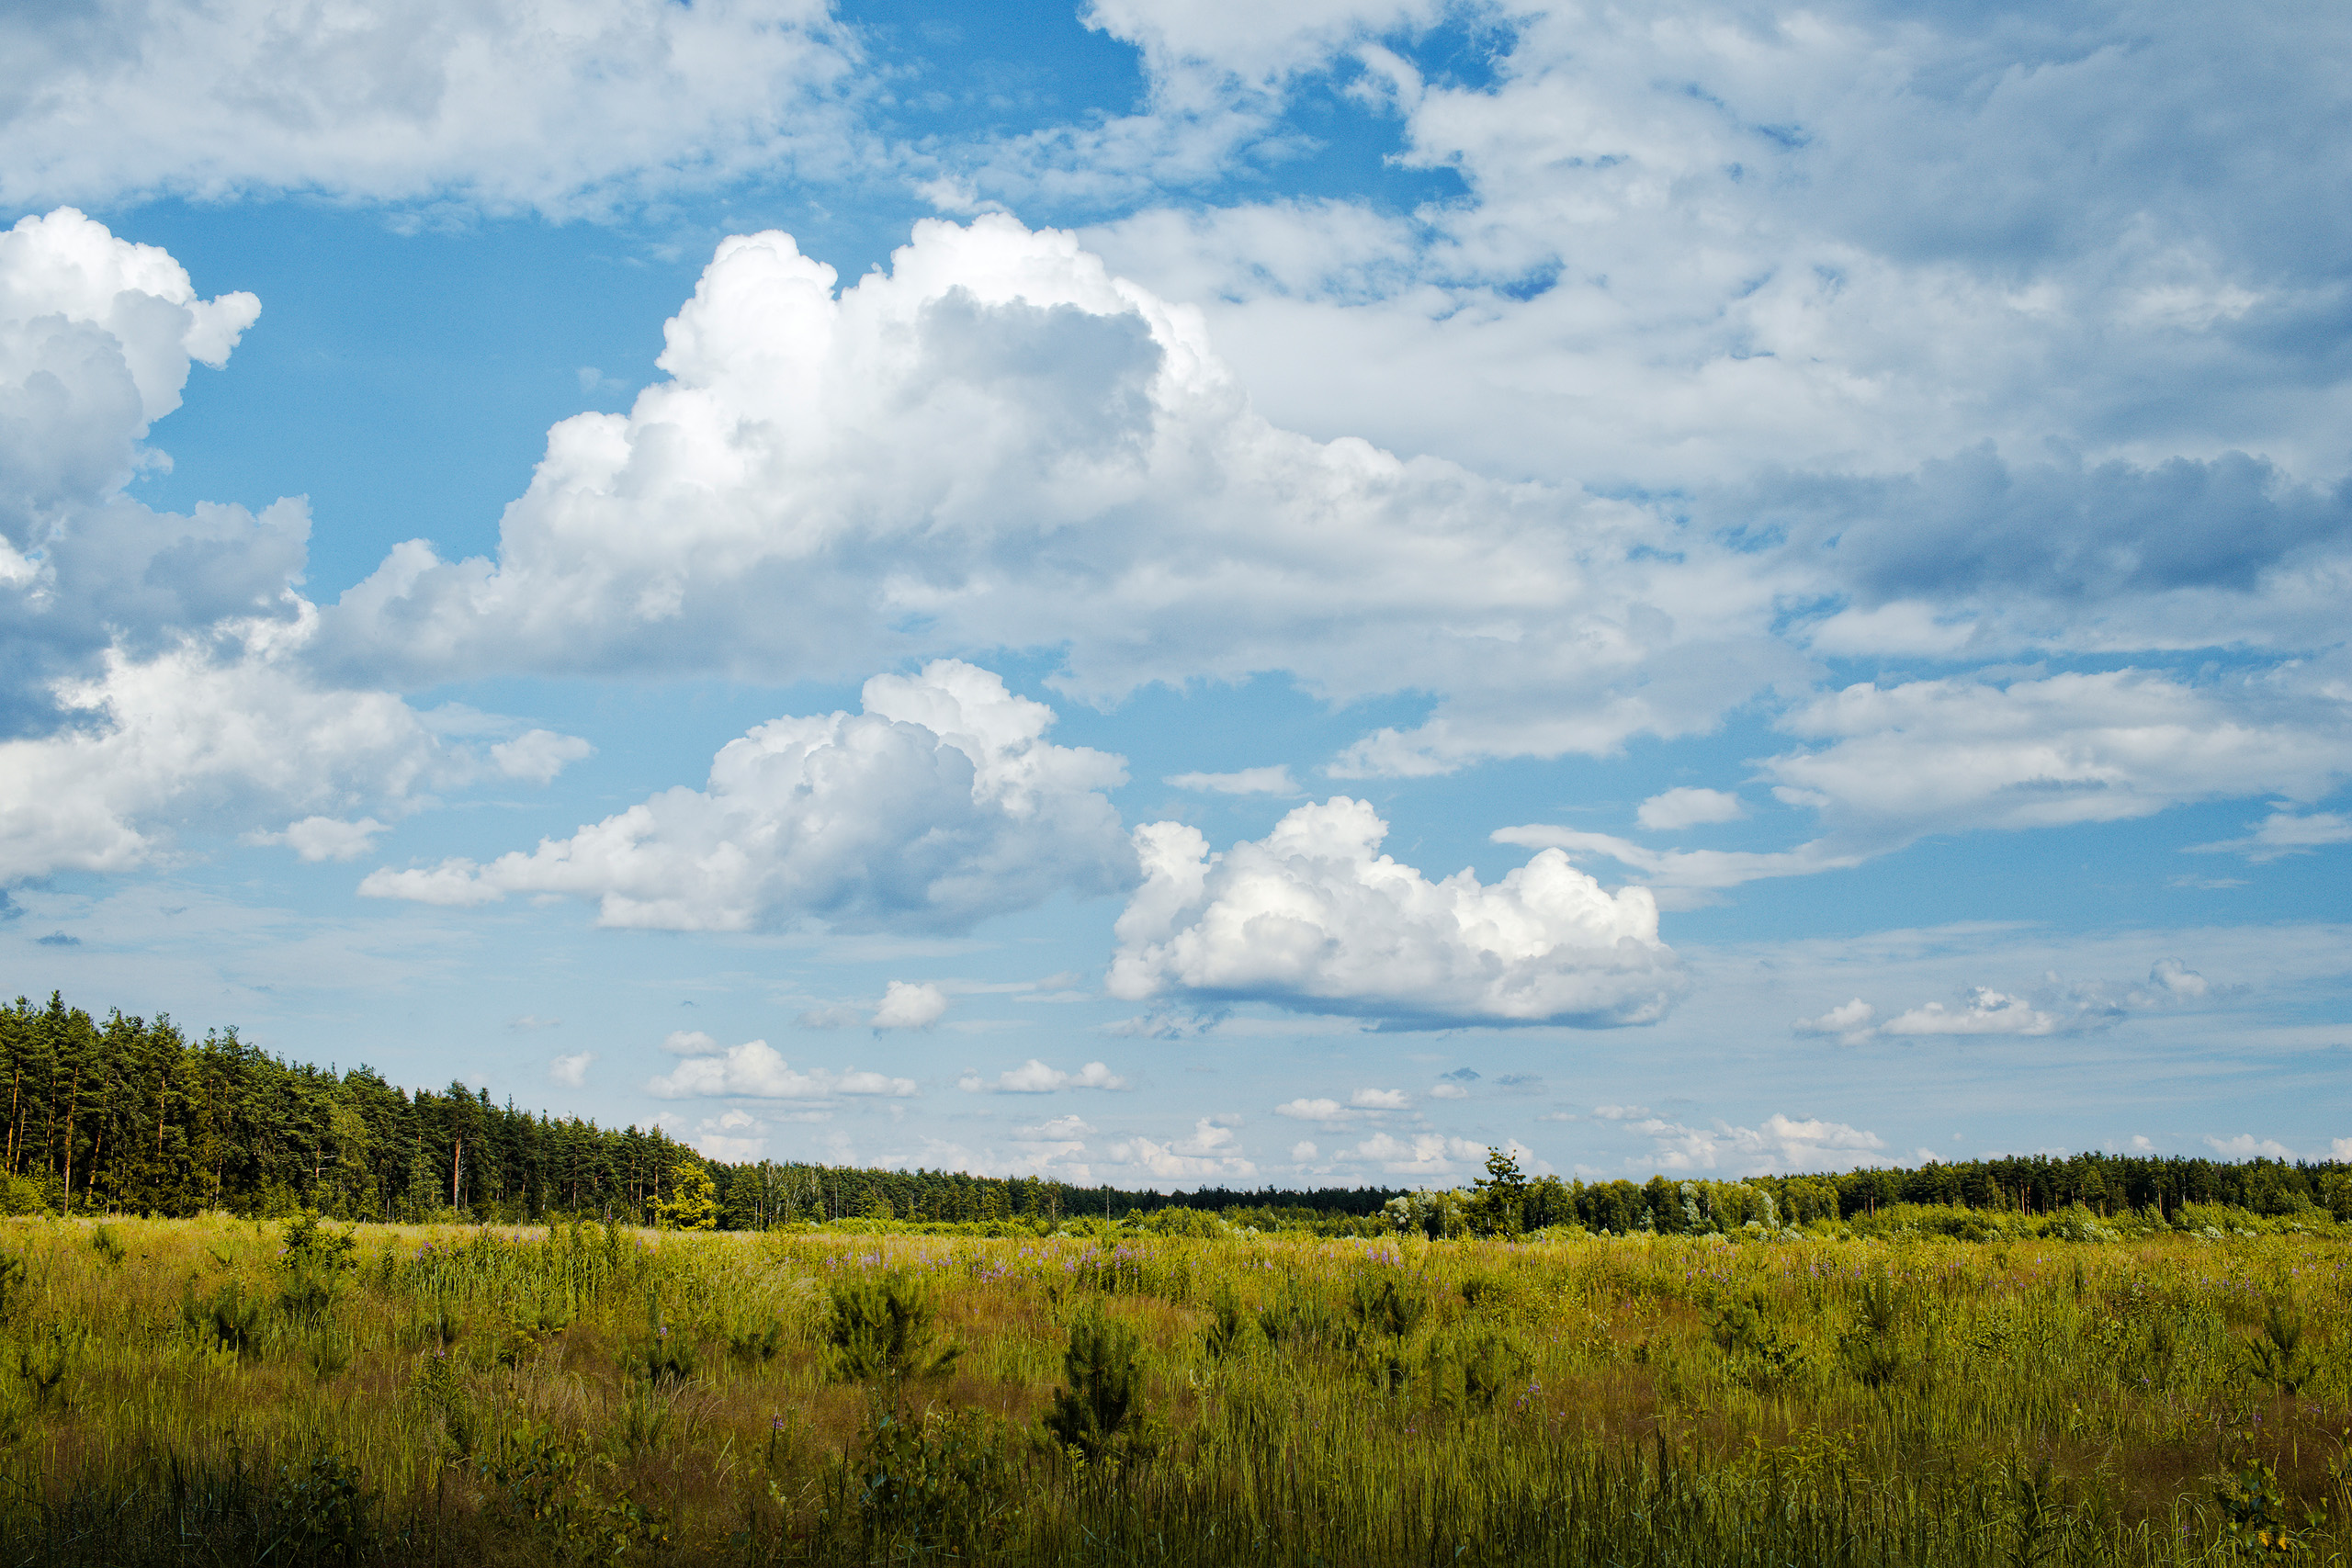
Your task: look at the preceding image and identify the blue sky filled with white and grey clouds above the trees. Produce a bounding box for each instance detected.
[0,0,2352,1187]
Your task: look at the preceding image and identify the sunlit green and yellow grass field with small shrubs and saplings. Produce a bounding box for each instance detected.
[0,1218,2352,1565]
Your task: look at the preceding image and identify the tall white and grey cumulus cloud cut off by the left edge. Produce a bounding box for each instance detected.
[0,209,583,882]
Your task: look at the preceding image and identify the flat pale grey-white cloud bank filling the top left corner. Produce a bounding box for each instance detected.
[0,0,856,216]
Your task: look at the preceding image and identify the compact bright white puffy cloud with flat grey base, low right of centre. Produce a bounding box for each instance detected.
[1108,795,1679,1025]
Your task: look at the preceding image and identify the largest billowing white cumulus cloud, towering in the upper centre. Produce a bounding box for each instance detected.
[332,216,1804,769]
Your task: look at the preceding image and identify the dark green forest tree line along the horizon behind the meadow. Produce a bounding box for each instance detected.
[0,995,2352,1235]
